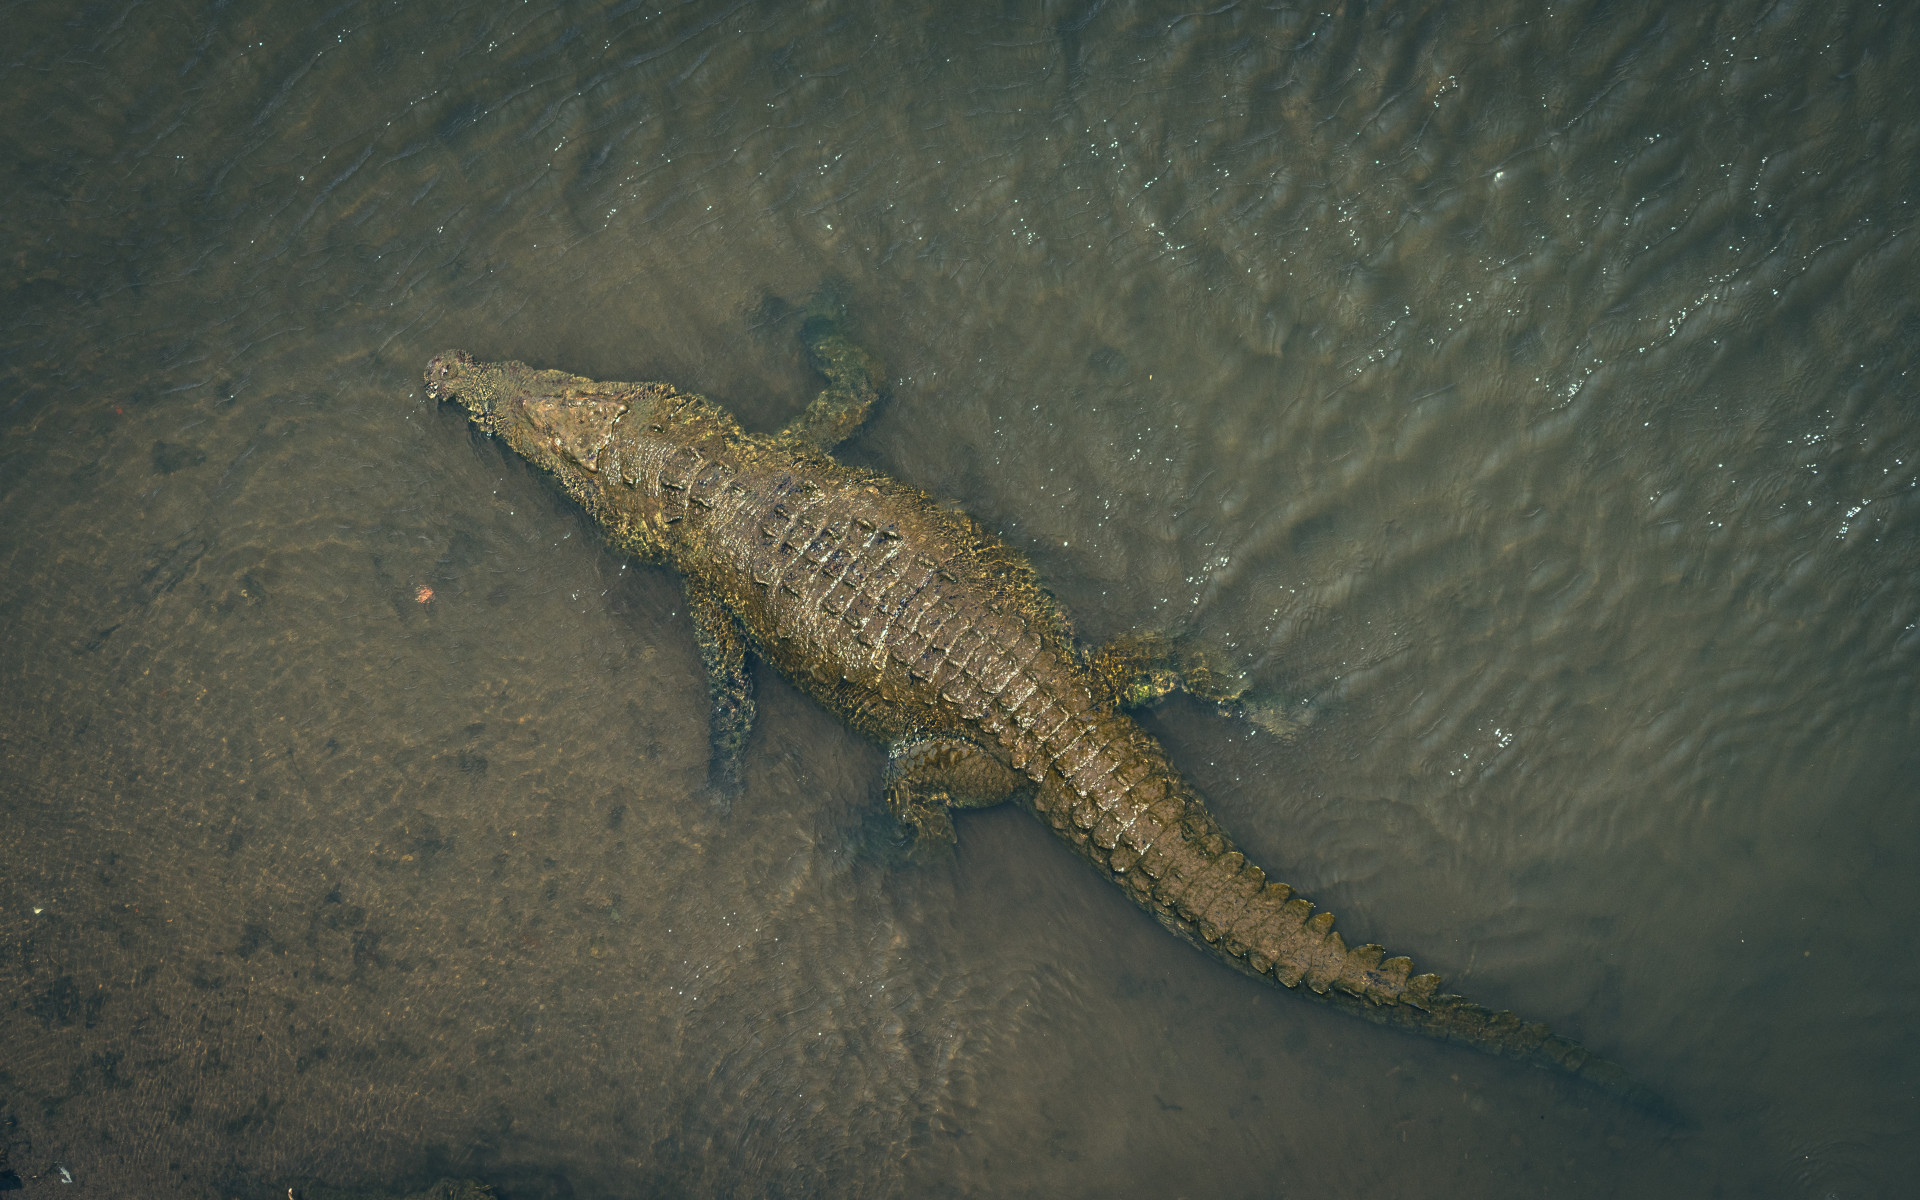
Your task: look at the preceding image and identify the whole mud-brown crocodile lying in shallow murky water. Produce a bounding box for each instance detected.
[426,317,1667,1114]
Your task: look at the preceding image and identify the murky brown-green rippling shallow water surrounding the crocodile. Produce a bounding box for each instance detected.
[0,0,1920,1200]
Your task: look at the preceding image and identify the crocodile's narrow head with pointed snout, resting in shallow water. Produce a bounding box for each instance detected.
[426,349,634,490]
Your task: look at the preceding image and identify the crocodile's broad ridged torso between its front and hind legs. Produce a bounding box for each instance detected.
[684,441,1091,741]
